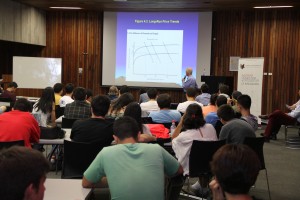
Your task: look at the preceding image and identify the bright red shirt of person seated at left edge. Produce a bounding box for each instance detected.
[0,110,40,148]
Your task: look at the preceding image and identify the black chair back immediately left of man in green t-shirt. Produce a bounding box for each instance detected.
[61,140,105,179]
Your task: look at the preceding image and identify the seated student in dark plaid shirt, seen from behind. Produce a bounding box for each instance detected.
[64,87,91,119]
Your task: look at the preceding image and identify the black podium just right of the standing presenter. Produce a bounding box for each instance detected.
[201,76,233,95]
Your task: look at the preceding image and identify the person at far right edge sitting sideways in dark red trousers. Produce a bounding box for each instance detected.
[258,89,300,142]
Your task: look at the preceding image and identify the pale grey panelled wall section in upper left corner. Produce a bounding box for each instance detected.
[0,0,46,46]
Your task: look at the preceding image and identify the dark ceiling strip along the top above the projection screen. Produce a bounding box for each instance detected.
[15,0,300,11]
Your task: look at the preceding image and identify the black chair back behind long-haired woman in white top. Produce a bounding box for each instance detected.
[189,140,226,177]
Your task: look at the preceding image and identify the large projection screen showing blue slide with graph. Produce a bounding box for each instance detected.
[102,12,212,88]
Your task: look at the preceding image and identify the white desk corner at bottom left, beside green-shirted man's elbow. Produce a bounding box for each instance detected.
[44,178,91,200]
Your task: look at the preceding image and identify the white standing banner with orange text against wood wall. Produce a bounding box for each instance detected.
[237,57,264,124]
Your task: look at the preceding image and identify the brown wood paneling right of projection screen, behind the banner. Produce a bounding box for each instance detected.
[211,9,300,113]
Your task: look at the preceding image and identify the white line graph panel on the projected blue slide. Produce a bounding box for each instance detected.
[126,29,183,83]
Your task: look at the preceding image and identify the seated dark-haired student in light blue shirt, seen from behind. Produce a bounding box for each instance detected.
[149,93,181,123]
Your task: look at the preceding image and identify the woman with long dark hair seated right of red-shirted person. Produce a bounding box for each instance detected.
[32,87,56,127]
